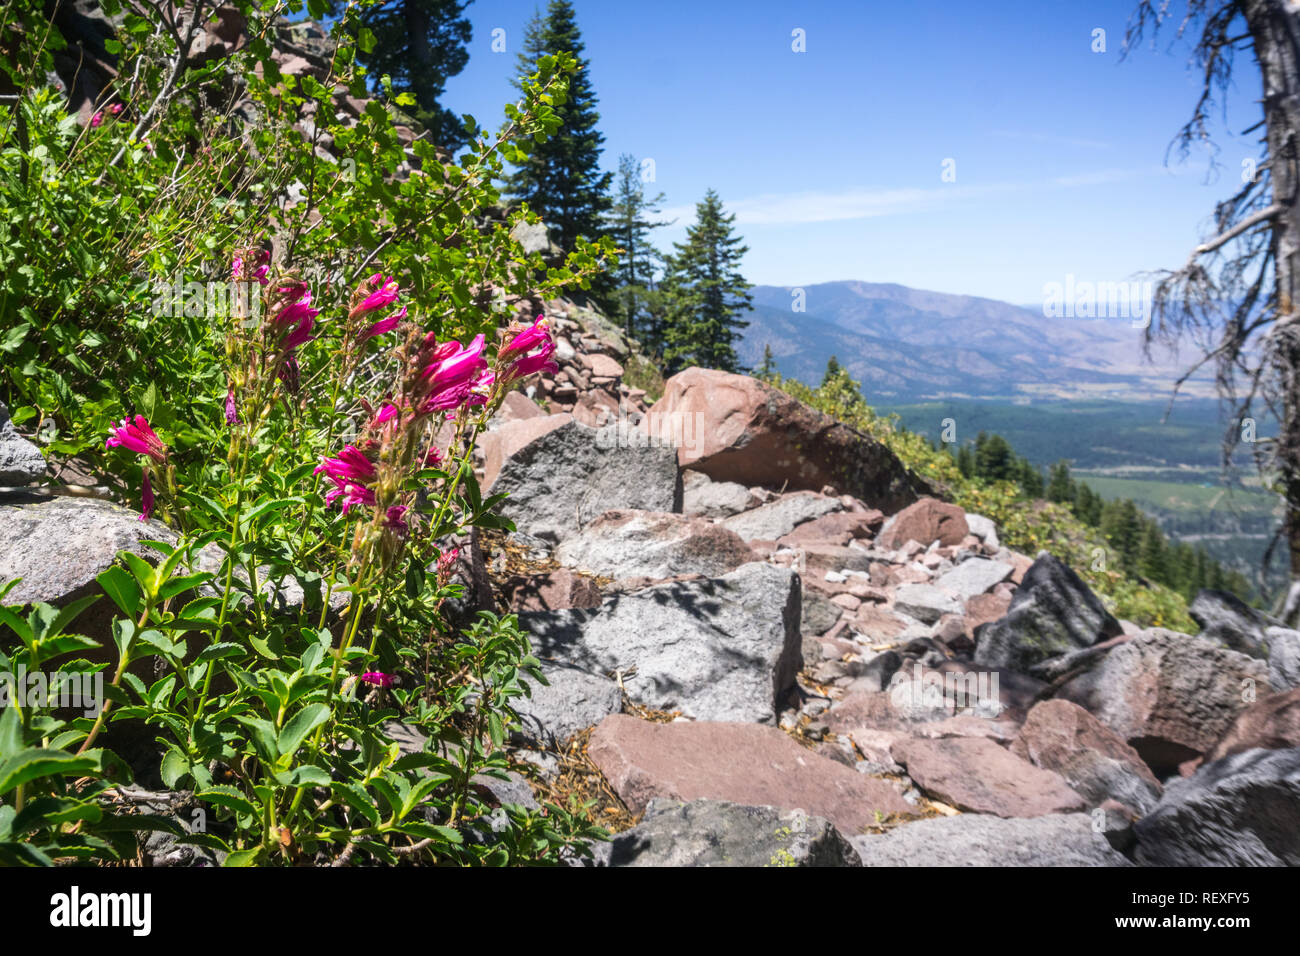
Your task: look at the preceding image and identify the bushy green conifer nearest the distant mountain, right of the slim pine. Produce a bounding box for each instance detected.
[660,190,751,373]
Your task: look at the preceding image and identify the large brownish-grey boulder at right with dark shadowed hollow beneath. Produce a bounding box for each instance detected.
[1056,628,1268,778]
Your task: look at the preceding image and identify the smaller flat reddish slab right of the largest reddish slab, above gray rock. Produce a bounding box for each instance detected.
[894,738,1087,817]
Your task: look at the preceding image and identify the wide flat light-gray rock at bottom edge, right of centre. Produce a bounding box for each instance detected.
[849,813,1132,866]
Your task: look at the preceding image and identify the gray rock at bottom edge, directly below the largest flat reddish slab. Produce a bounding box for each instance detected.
[597,800,859,866]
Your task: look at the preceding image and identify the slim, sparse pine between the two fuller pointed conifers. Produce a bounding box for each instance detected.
[607,153,668,354]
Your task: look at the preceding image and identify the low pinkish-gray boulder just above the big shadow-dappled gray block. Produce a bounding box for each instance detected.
[555,511,755,579]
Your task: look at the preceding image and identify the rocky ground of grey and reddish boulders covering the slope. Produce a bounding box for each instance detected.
[0,306,1300,866]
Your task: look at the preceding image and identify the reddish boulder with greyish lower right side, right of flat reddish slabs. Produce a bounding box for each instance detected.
[1011,700,1161,813]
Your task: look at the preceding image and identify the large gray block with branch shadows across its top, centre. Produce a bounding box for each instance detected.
[519,562,801,723]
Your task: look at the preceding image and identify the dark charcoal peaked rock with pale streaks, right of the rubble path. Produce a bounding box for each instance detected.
[975,551,1121,674]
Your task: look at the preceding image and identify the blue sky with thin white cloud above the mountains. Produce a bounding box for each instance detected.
[443,0,1258,304]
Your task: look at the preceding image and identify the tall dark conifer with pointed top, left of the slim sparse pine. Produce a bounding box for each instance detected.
[506,0,614,251]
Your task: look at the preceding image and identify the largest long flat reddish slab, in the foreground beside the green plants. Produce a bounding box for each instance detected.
[588,714,914,835]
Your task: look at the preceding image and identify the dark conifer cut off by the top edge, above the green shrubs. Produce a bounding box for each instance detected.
[358,0,473,151]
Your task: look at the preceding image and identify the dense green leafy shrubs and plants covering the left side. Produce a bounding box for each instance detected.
[0,0,601,865]
